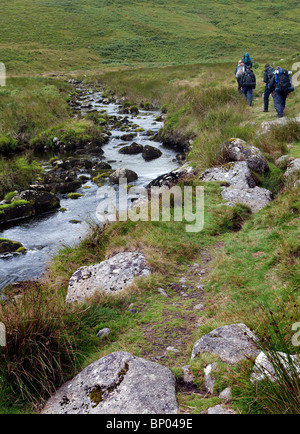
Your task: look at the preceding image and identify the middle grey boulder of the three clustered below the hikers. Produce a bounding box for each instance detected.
[199,161,256,189]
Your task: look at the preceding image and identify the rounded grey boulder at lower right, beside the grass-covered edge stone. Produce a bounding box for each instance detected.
[192,324,259,365]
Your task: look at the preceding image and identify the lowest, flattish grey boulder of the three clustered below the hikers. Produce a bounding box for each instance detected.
[221,187,273,213]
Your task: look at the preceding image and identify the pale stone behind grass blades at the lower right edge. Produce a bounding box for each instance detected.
[251,352,300,383]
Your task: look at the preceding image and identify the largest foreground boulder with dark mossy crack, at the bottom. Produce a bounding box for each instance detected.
[43,352,178,414]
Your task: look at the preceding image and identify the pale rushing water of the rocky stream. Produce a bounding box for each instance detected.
[0,91,178,290]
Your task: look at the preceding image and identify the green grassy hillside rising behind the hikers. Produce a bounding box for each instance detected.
[0,0,300,73]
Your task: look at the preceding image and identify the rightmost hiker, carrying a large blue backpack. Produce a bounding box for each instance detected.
[269,66,295,118]
